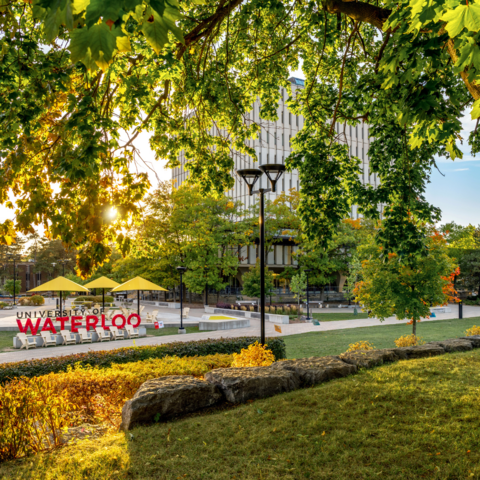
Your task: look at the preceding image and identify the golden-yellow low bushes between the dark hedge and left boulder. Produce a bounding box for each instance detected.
[0,354,233,461]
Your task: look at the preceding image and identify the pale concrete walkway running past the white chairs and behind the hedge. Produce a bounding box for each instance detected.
[0,305,480,363]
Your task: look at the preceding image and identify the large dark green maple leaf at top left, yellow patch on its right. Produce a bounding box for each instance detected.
[70,22,130,70]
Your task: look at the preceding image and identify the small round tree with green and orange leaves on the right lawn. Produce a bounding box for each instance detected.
[354,232,459,335]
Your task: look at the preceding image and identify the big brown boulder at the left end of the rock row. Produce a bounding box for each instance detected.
[120,375,223,430]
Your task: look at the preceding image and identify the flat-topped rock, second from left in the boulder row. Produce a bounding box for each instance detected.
[205,367,300,403]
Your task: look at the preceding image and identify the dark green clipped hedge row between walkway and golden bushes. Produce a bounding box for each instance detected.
[0,337,286,384]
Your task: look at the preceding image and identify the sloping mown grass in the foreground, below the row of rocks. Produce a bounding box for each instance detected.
[0,351,480,480]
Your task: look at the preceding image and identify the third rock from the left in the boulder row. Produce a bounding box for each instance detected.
[271,356,357,387]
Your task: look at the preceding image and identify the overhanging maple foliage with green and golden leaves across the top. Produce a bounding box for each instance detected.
[0,0,480,275]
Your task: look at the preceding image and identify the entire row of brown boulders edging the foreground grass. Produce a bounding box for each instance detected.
[121,335,480,430]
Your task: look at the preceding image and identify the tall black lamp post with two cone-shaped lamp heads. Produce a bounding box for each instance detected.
[237,163,285,345]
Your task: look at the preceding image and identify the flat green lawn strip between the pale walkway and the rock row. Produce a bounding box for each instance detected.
[283,317,480,358]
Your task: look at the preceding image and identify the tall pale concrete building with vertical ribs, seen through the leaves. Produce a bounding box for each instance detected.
[172,77,378,293]
